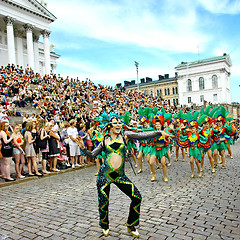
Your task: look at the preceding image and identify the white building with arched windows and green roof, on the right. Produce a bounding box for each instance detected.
[175,53,232,106]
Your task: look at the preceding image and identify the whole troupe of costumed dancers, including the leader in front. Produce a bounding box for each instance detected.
[78,106,237,237]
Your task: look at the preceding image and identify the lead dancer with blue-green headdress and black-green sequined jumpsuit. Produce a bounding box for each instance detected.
[78,113,171,237]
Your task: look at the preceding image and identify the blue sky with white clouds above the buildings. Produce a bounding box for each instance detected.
[45,0,240,102]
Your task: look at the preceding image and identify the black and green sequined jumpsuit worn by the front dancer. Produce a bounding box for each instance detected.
[83,131,161,229]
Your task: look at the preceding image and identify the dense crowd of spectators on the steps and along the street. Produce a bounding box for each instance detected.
[0,65,238,181]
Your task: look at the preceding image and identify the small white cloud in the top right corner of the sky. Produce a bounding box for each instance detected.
[198,0,240,14]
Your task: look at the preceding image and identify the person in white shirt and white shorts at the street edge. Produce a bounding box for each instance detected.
[67,119,80,168]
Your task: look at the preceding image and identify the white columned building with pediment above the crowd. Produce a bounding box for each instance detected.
[0,0,60,75]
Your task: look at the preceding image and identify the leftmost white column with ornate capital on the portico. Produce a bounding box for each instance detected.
[5,16,16,65]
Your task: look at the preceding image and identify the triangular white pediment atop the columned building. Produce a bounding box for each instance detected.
[0,0,56,22]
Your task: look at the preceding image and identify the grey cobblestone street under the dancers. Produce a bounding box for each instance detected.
[0,141,240,240]
